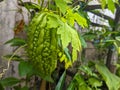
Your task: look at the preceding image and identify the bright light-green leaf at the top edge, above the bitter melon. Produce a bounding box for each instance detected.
[55,0,68,14]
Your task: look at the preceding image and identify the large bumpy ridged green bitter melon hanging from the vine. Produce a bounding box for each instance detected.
[27,13,57,79]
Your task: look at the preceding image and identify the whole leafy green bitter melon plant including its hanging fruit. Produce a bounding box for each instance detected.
[0,0,120,90]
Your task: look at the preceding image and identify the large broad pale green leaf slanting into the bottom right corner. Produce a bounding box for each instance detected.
[96,64,120,90]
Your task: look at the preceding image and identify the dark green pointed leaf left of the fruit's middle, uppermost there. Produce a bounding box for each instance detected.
[5,38,26,46]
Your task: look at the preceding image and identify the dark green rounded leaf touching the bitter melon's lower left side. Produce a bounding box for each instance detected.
[18,61,33,76]
